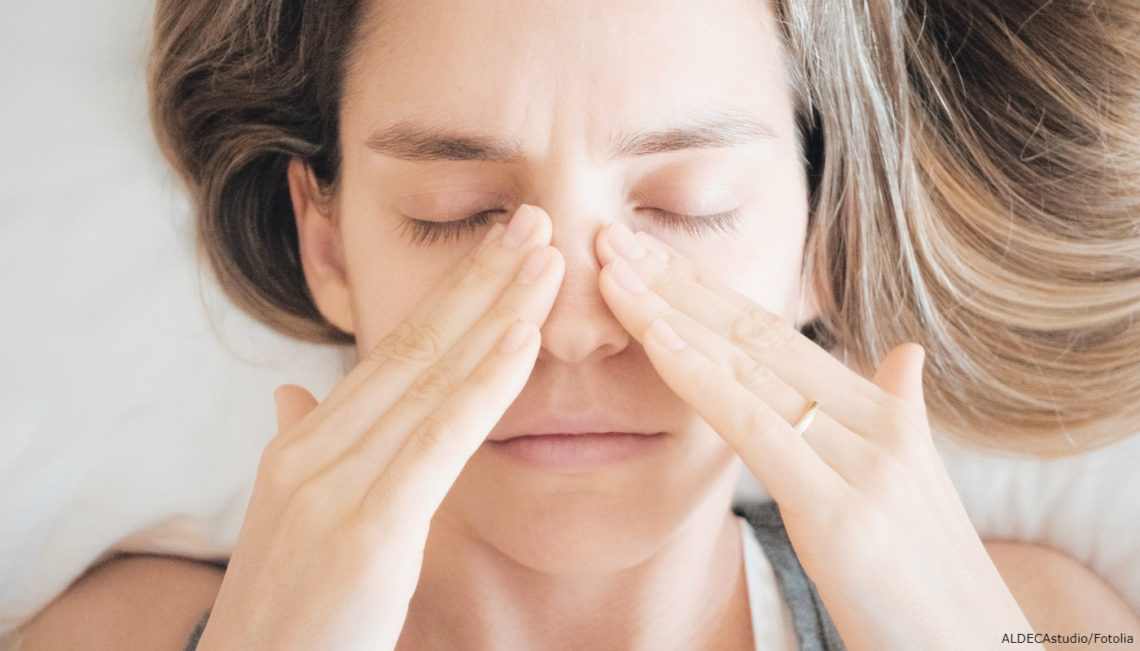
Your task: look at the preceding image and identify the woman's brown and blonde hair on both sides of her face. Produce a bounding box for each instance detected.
[149,0,1140,455]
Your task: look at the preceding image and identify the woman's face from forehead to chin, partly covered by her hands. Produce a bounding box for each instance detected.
[294,0,807,571]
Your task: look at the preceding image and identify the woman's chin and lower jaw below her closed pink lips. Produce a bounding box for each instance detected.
[433,434,740,576]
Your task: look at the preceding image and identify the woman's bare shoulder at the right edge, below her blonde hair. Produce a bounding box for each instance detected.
[985,540,1140,637]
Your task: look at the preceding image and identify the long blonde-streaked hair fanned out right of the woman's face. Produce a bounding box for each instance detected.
[782,0,1140,455]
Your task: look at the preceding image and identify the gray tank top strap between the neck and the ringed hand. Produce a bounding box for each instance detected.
[733,502,845,651]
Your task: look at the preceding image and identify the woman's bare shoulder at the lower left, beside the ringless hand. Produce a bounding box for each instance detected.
[21,555,222,651]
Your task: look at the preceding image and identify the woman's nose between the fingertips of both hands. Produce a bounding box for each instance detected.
[538,214,630,363]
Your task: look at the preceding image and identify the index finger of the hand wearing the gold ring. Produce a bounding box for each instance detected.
[599,223,886,434]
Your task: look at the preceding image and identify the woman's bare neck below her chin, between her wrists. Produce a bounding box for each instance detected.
[398,503,752,651]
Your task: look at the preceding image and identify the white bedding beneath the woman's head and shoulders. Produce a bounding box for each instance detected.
[0,0,1140,636]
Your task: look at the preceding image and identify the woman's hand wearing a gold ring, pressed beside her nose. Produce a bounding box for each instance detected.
[597,225,1040,650]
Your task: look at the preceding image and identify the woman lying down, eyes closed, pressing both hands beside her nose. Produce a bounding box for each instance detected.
[15,0,1140,649]
